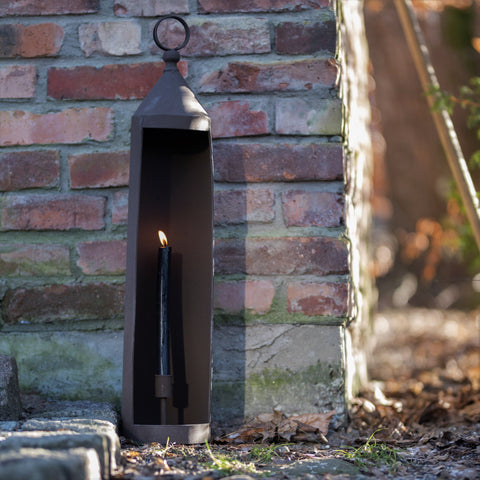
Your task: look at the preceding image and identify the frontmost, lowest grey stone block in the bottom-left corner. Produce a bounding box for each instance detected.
[0,448,101,480]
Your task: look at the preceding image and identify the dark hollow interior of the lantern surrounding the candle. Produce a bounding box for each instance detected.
[129,128,213,425]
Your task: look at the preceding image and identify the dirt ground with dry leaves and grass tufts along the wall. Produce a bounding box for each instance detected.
[114,309,480,480]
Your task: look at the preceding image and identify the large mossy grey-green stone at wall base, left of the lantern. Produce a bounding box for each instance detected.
[0,331,123,405]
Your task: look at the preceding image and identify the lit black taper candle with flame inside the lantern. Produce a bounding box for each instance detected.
[157,232,172,375]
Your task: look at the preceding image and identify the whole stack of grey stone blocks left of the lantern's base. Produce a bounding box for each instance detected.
[0,402,120,480]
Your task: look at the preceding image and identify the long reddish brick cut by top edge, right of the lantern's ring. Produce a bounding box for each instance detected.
[198,0,332,13]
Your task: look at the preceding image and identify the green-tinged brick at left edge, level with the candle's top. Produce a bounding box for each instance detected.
[0,244,70,277]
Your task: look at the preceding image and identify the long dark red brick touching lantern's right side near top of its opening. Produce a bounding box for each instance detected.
[213,142,343,182]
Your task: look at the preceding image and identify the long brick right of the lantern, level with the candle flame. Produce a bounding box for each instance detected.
[215,237,348,275]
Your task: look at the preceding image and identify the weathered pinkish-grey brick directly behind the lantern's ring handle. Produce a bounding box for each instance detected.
[152,18,271,57]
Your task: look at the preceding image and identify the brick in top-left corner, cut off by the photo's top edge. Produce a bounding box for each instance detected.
[0,0,100,17]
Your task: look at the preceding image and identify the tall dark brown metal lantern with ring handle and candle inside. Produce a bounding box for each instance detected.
[122,16,213,443]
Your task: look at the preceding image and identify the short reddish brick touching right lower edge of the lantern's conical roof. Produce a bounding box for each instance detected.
[208,100,269,138]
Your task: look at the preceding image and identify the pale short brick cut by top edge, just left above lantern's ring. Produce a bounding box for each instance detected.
[113,0,190,17]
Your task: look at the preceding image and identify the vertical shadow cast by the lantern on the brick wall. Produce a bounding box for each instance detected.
[212,158,249,424]
